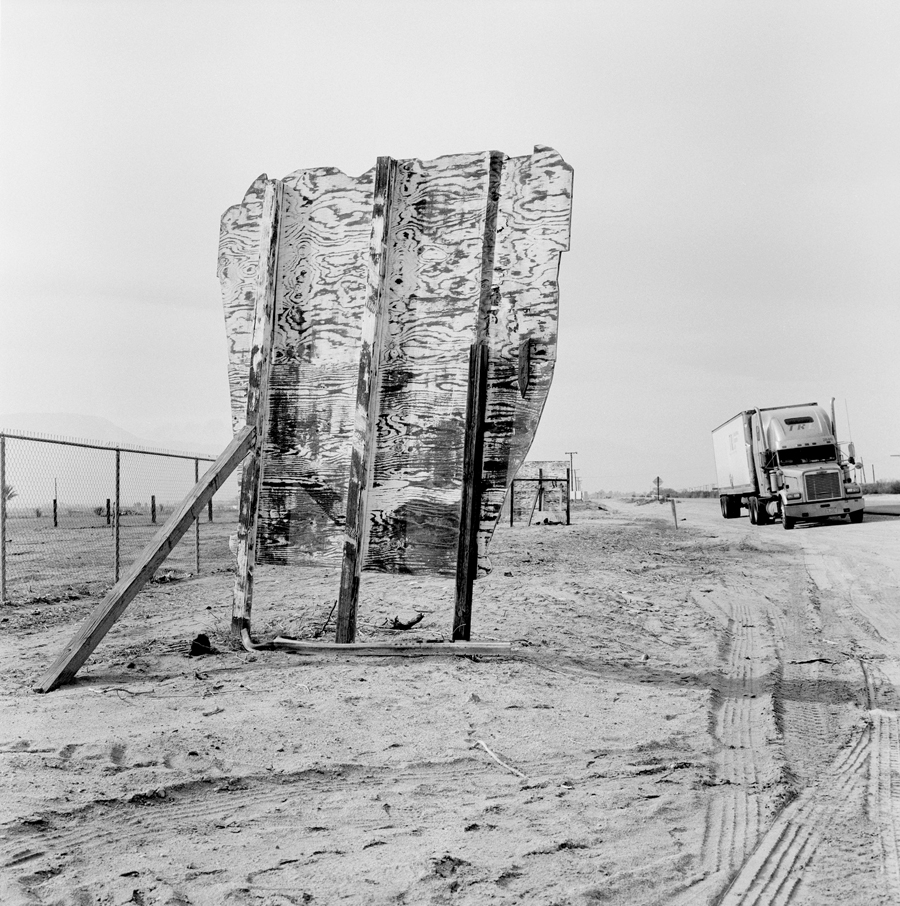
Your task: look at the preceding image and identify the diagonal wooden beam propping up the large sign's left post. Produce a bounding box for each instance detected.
[35,427,255,692]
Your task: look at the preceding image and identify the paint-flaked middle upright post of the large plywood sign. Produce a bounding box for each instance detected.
[335,157,397,643]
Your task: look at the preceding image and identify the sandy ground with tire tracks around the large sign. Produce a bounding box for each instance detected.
[0,500,900,906]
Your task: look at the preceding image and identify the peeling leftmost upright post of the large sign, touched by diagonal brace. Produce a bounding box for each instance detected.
[231,180,284,639]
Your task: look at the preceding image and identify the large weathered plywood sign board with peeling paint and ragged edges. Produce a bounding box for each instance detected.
[219,147,572,574]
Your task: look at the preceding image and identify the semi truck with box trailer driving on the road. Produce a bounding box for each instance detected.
[713,399,865,529]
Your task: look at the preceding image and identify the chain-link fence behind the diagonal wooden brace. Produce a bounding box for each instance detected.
[0,432,238,602]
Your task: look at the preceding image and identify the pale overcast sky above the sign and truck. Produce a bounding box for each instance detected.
[0,0,900,490]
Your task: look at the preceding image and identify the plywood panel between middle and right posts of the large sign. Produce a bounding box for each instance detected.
[366,152,500,575]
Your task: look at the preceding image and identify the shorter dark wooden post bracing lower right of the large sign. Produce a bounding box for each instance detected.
[453,343,488,642]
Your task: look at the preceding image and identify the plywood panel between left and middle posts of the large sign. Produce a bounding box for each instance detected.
[259,162,374,565]
